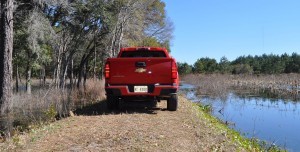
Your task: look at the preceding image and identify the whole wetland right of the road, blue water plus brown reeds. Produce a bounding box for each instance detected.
[182,74,300,151]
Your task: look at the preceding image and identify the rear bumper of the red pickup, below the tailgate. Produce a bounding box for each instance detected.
[105,85,178,97]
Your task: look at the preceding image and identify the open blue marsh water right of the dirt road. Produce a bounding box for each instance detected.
[180,83,300,152]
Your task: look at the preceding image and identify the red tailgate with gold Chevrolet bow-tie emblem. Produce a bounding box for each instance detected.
[108,58,173,85]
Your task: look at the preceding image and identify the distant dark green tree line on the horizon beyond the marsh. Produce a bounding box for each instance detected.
[178,53,300,75]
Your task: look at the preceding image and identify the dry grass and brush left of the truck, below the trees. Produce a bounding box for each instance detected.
[1,80,105,139]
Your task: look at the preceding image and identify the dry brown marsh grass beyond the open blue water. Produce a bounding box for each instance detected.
[183,74,300,99]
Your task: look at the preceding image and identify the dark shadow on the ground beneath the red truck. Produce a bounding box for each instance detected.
[73,100,166,116]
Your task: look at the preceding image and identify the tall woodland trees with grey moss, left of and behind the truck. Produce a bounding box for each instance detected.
[0,0,174,136]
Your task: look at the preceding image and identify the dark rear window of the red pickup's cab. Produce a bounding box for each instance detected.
[121,51,167,58]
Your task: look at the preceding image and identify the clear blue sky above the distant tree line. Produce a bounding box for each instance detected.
[163,0,300,64]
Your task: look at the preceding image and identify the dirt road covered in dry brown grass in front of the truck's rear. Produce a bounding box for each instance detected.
[8,97,244,151]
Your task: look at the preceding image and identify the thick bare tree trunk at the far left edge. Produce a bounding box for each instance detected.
[0,0,14,137]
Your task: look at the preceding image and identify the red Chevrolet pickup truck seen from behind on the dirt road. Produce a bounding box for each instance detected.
[104,47,179,111]
